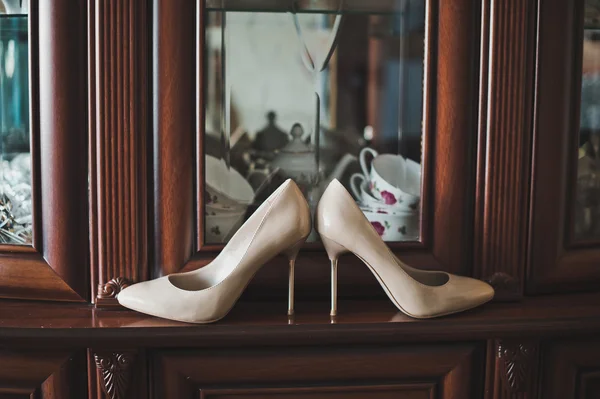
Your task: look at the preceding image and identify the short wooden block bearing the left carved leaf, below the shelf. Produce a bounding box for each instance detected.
[88,349,148,399]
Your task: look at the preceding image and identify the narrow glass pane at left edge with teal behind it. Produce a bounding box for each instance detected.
[0,0,32,245]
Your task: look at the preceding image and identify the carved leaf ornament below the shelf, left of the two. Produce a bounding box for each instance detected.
[94,352,135,399]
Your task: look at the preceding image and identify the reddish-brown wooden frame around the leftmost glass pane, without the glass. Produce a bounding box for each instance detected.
[0,0,88,301]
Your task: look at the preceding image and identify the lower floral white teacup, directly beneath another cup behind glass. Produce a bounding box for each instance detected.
[360,206,419,242]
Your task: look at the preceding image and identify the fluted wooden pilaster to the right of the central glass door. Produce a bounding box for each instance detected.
[474,0,536,299]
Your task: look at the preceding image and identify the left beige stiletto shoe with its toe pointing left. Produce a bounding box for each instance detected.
[117,180,312,323]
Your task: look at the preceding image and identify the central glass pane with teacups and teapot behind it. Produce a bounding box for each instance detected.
[204,0,426,243]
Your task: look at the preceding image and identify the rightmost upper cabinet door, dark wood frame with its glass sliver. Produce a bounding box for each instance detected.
[527,0,600,293]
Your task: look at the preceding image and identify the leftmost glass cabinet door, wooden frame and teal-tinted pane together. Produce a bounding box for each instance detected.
[0,0,89,302]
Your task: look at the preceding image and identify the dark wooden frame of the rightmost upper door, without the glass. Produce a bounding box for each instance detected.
[527,0,600,293]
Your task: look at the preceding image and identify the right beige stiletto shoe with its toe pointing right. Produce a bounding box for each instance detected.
[315,180,494,319]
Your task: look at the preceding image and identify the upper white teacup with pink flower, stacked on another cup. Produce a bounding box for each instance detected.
[360,148,421,205]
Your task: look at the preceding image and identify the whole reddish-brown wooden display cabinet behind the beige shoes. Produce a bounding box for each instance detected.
[0,0,600,399]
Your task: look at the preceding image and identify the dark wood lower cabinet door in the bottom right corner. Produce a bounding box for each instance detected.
[541,341,600,399]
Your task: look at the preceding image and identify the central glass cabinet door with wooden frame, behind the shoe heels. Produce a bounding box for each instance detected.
[152,0,481,292]
